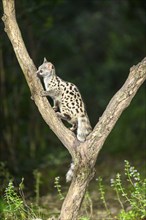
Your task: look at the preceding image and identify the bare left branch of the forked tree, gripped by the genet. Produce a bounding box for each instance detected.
[2,0,79,161]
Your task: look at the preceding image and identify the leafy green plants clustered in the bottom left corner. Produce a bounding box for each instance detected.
[0,178,49,220]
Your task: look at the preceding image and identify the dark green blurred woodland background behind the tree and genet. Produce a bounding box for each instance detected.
[0,0,146,205]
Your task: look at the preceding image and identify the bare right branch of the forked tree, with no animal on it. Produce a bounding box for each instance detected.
[87,58,146,160]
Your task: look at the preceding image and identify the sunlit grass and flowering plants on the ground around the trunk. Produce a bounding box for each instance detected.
[0,157,146,220]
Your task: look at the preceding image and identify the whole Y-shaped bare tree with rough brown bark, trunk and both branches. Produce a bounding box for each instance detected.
[2,0,146,220]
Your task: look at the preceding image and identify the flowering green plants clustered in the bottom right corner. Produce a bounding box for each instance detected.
[117,160,146,220]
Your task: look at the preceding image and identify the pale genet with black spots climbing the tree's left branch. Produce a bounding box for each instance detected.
[37,58,92,181]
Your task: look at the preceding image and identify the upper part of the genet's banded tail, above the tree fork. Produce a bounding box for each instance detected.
[77,115,92,142]
